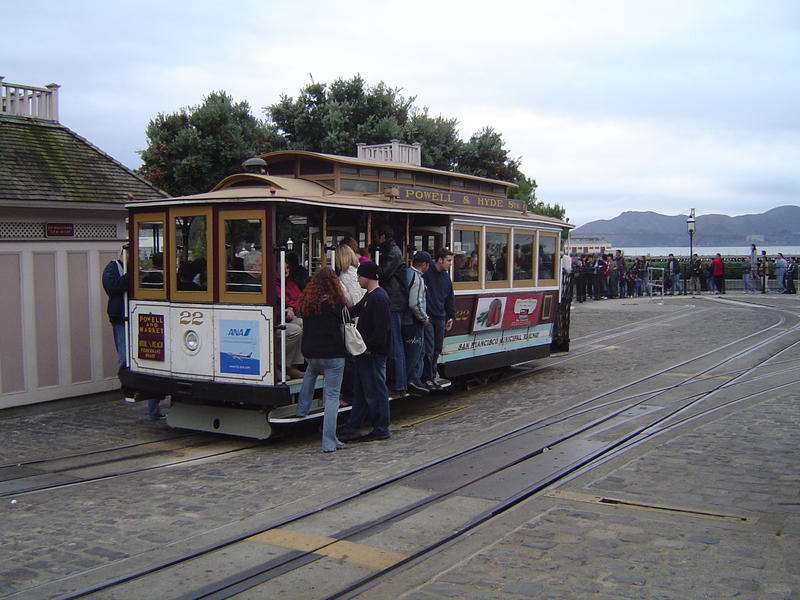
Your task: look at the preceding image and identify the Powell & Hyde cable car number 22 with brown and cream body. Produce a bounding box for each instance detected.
[120,142,571,439]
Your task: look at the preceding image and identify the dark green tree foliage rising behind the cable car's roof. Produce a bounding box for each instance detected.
[140,75,565,224]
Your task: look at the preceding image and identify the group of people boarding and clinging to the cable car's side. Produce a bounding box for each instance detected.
[284,225,455,452]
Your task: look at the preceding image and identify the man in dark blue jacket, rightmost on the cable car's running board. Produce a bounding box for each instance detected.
[422,248,456,390]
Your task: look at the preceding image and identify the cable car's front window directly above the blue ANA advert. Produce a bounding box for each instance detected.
[225,219,263,293]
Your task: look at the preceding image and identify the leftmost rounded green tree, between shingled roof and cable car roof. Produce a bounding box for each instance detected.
[139,91,286,196]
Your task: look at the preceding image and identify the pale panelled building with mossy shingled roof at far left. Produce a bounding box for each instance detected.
[0,77,166,408]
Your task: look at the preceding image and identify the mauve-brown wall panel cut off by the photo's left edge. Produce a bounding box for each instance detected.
[0,254,25,393]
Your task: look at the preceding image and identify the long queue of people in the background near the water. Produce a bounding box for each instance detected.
[569,244,797,302]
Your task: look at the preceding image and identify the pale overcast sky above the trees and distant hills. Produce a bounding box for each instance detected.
[0,0,800,225]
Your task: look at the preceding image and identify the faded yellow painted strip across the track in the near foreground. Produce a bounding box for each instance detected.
[247,529,406,570]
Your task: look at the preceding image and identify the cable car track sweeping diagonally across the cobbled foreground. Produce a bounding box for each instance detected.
[43,302,800,598]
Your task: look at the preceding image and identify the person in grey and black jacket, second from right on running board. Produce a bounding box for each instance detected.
[403,250,431,396]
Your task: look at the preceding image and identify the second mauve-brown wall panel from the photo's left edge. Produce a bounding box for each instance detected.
[33,252,58,387]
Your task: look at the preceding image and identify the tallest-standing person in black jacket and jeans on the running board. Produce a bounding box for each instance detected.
[376,224,408,395]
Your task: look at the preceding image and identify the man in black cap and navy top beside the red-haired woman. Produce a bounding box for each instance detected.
[339,261,392,442]
